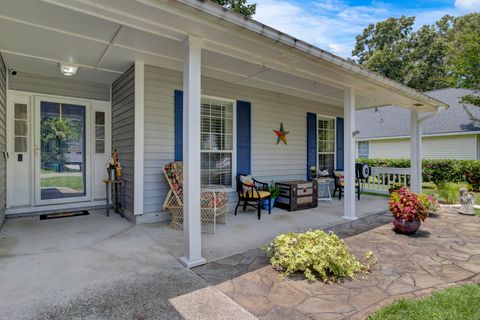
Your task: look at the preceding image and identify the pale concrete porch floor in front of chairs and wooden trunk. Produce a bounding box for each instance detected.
[141,195,387,262]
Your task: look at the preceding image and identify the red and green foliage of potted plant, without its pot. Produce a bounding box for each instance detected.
[388,187,428,222]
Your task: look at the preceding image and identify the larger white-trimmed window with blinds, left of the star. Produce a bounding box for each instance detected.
[200,97,234,188]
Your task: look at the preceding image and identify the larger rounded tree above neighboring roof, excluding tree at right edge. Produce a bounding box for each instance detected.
[352,16,452,91]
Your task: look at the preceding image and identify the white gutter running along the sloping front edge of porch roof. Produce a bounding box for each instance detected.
[176,0,448,109]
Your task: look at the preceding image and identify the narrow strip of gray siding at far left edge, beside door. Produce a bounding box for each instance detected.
[0,54,7,226]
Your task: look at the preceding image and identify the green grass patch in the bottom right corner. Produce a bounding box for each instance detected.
[368,284,480,320]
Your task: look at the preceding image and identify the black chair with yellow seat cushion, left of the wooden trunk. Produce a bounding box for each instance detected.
[235,174,271,220]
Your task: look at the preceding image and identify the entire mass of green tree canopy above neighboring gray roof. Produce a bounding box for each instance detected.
[352,13,480,119]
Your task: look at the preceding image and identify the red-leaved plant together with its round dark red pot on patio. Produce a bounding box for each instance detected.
[388,187,428,234]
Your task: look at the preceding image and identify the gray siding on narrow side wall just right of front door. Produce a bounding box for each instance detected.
[112,66,135,218]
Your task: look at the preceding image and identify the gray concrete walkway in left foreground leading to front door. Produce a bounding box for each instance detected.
[0,211,255,320]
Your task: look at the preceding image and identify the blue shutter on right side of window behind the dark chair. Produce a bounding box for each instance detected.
[237,101,252,174]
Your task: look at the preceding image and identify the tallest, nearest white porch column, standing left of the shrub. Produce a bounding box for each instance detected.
[180,35,206,268]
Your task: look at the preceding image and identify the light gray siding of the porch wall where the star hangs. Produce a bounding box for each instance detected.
[144,66,343,213]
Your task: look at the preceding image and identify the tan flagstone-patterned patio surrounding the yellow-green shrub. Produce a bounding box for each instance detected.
[194,209,480,320]
